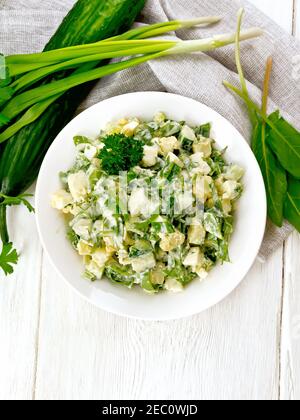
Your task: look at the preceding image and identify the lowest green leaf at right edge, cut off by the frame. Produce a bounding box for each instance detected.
[284,177,300,232]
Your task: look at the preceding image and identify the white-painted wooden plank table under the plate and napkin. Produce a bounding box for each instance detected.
[0,0,300,400]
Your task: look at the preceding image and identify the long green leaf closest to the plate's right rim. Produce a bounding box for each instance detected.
[252,121,287,227]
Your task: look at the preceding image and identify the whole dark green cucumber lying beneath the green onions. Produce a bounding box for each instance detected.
[0,0,146,242]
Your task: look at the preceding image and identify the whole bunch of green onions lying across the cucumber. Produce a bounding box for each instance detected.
[0,16,262,143]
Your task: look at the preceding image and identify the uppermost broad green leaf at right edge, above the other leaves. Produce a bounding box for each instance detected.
[268,111,300,179]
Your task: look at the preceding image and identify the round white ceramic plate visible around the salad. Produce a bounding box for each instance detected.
[36,92,266,320]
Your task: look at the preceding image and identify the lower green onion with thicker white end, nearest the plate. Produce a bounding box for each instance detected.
[0,28,262,143]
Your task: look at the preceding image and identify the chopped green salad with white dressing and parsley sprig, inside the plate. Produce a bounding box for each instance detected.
[51,112,244,293]
